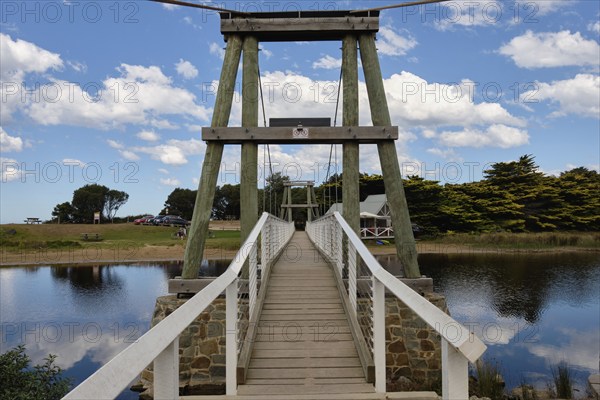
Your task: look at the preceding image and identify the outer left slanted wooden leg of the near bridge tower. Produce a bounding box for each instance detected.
[181,35,242,279]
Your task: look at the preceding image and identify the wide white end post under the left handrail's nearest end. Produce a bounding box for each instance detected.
[154,336,179,400]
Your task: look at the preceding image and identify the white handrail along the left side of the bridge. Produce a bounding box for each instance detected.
[63,213,291,400]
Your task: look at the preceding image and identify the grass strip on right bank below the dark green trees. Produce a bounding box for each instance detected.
[430,232,600,250]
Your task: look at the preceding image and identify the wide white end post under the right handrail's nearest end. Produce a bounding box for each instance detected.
[442,338,469,400]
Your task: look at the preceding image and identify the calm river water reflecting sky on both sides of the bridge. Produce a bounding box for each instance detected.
[0,253,600,399]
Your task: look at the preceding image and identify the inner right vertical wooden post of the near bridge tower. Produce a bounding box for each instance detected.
[342,35,360,238]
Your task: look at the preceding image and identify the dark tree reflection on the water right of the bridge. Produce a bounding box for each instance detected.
[419,253,600,324]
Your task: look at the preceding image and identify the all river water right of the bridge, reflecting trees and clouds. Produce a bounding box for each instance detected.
[379,253,600,392]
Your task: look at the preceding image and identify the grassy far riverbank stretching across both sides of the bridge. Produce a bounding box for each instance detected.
[0,221,600,266]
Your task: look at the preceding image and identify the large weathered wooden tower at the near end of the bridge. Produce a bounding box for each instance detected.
[182,10,421,279]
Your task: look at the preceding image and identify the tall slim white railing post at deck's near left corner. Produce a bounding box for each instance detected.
[225,279,239,396]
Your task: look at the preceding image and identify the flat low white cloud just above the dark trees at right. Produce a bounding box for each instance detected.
[439,124,529,149]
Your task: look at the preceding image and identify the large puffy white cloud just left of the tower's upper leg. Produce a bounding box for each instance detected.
[29,64,210,129]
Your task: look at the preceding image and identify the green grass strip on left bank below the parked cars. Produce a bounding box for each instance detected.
[0,223,240,251]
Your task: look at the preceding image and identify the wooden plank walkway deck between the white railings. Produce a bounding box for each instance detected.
[238,232,374,395]
